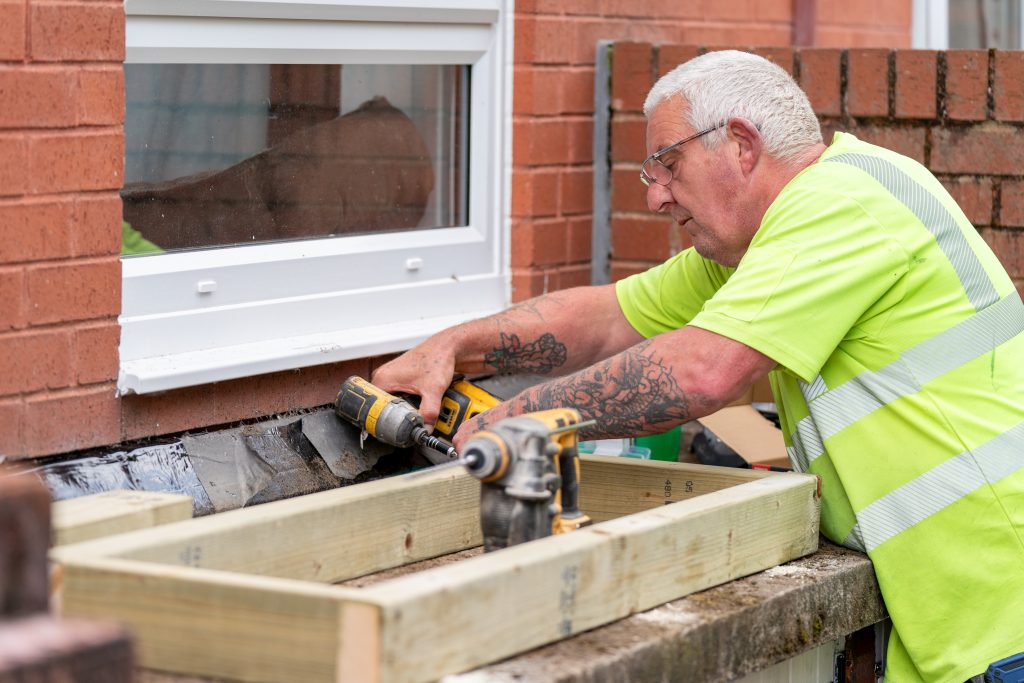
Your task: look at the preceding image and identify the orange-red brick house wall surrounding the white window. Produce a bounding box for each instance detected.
[0,0,913,458]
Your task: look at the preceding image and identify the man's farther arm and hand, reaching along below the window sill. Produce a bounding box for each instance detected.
[371,285,642,425]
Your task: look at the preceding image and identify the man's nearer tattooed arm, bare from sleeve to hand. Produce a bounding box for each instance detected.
[455,327,776,447]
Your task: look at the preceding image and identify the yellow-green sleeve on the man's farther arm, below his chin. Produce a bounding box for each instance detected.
[615,249,732,338]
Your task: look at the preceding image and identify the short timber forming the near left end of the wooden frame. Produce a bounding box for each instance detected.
[62,558,359,683]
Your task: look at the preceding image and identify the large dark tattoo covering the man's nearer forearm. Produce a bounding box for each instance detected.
[520,340,701,438]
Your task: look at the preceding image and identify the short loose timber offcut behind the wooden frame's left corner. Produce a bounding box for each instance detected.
[52,490,193,546]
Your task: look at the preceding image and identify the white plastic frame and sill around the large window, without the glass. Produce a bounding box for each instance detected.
[118,0,512,393]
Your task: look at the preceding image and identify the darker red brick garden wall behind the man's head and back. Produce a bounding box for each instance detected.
[610,42,1024,299]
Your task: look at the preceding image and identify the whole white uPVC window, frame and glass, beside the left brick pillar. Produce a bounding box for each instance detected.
[119,0,510,393]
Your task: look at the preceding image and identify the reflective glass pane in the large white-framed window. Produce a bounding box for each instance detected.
[122,63,469,255]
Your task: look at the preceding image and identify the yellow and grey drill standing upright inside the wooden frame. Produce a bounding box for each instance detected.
[462,408,591,552]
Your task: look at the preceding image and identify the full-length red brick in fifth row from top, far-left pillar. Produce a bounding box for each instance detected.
[28,258,121,325]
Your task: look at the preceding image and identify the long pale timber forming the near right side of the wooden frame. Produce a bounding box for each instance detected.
[356,474,819,683]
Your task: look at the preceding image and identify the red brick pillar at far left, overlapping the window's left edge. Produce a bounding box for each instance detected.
[0,0,125,457]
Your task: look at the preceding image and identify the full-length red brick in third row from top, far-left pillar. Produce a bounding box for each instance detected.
[29,131,125,194]
